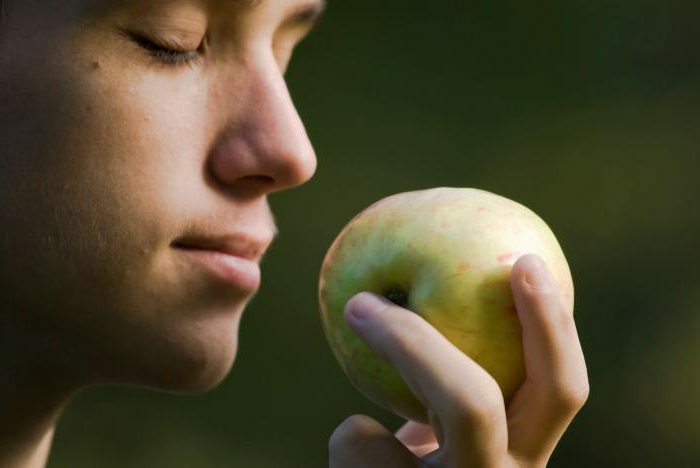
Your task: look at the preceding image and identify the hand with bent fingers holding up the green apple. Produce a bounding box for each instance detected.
[329,255,589,468]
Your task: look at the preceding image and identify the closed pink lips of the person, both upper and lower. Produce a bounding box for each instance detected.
[171,233,272,292]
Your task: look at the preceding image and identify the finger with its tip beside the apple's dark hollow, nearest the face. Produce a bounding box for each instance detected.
[344,293,507,466]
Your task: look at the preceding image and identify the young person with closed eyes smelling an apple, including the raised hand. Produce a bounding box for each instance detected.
[0,0,589,468]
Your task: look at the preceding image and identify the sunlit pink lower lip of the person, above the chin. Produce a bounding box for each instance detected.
[176,247,260,293]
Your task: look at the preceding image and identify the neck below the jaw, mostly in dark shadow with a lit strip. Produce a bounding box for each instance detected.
[0,321,83,468]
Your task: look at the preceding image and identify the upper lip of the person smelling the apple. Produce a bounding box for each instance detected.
[172,233,273,262]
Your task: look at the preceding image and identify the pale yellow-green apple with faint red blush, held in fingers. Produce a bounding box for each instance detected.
[319,187,574,423]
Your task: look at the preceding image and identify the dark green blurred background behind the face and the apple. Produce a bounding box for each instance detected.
[49,0,700,468]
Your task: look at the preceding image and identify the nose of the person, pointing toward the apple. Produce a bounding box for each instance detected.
[208,51,316,196]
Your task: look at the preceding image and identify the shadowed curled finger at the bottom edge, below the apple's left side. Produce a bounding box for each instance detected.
[328,414,421,468]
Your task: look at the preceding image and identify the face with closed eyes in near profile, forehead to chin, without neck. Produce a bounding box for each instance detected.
[0,0,320,392]
